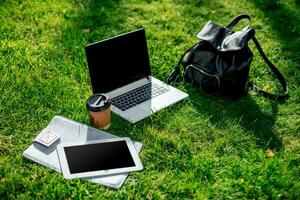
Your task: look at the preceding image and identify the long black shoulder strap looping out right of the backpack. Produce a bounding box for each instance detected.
[249,36,288,100]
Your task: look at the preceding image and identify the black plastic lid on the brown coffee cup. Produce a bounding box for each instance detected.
[86,93,111,112]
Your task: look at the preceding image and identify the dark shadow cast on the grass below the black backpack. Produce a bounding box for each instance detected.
[190,89,282,149]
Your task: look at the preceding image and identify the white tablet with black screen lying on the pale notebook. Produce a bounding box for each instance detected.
[57,138,143,179]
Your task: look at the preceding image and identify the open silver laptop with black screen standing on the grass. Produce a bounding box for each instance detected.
[85,28,188,123]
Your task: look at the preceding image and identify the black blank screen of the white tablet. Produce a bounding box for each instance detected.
[64,141,135,174]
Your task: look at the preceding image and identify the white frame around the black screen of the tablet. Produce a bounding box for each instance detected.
[57,137,143,179]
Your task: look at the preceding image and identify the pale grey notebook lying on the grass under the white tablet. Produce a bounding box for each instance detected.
[23,116,143,188]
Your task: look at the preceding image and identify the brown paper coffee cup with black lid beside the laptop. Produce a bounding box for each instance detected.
[86,93,111,129]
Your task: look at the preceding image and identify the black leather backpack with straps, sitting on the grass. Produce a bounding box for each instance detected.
[167,14,288,99]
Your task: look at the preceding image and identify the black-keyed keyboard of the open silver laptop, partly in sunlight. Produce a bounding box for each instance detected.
[111,82,169,111]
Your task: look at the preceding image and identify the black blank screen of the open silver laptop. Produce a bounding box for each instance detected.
[85,29,151,93]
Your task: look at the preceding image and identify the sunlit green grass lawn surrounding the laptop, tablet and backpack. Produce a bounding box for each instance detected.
[0,0,300,199]
